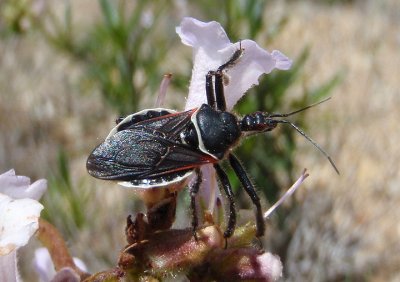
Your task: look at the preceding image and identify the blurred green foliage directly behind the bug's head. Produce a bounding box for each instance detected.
[235,48,341,202]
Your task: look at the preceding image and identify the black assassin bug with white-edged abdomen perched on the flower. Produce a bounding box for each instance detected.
[86,48,338,238]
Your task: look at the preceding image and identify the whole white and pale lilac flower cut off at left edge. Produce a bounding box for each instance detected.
[0,170,47,281]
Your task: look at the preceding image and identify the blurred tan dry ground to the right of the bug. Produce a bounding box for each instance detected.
[278,1,400,281]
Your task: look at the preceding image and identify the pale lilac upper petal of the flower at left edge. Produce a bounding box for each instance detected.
[0,169,47,200]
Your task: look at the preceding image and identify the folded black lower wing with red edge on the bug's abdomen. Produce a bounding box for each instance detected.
[87,127,214,186]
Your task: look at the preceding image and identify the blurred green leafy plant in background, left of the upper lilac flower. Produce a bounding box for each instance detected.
[36,0,174,115]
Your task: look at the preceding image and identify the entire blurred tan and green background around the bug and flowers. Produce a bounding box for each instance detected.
[0,0,400,281]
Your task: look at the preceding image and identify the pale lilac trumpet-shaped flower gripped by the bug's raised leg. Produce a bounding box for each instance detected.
[176,18,292,211]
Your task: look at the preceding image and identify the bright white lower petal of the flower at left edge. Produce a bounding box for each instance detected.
[0,194,43,256]
